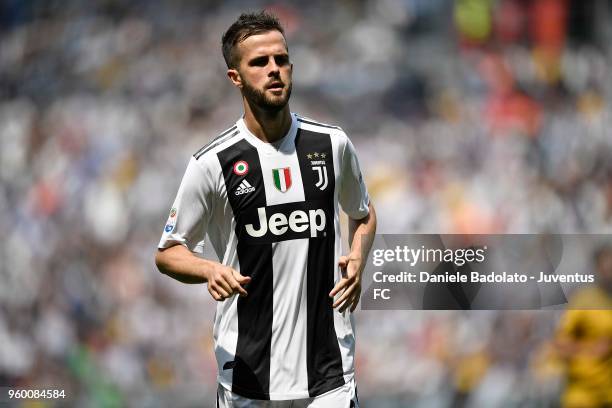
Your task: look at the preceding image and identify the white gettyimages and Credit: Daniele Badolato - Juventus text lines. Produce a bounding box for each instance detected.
[372,246,595,283]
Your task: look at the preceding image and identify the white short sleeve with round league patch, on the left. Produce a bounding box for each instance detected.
[158,157,215,253]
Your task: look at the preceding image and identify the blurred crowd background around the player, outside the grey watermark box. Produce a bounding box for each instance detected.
[0,0,612,408]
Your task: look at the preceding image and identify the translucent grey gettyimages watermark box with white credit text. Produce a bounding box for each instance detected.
[362,234,612,310]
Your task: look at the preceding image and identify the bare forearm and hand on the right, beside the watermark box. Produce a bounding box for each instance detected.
[329,202,376,312]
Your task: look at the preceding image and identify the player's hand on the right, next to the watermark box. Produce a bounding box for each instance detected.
[329,254,363,313]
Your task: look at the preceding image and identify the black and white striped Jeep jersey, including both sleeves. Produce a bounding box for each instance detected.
[159,114,369,400]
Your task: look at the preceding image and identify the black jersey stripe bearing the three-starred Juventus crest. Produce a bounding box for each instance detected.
[295,129,344,397]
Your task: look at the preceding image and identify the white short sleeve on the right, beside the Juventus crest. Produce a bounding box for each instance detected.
[338,133,370,220]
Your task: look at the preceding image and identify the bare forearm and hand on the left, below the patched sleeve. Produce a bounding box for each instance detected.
[155,245,251,300]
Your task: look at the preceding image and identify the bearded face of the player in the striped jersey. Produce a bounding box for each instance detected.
[229,30,293,112]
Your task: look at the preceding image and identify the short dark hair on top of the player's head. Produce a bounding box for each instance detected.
[221,10,286,68]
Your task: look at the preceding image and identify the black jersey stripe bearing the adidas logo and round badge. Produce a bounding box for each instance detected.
[217,139,273,399]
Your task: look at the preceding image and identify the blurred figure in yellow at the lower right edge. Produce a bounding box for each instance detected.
[557,246,612,408]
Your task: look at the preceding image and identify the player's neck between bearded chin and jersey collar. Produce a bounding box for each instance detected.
[244,99,291,143]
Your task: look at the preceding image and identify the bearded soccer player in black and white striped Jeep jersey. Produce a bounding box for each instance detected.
[156,12,376,408]
